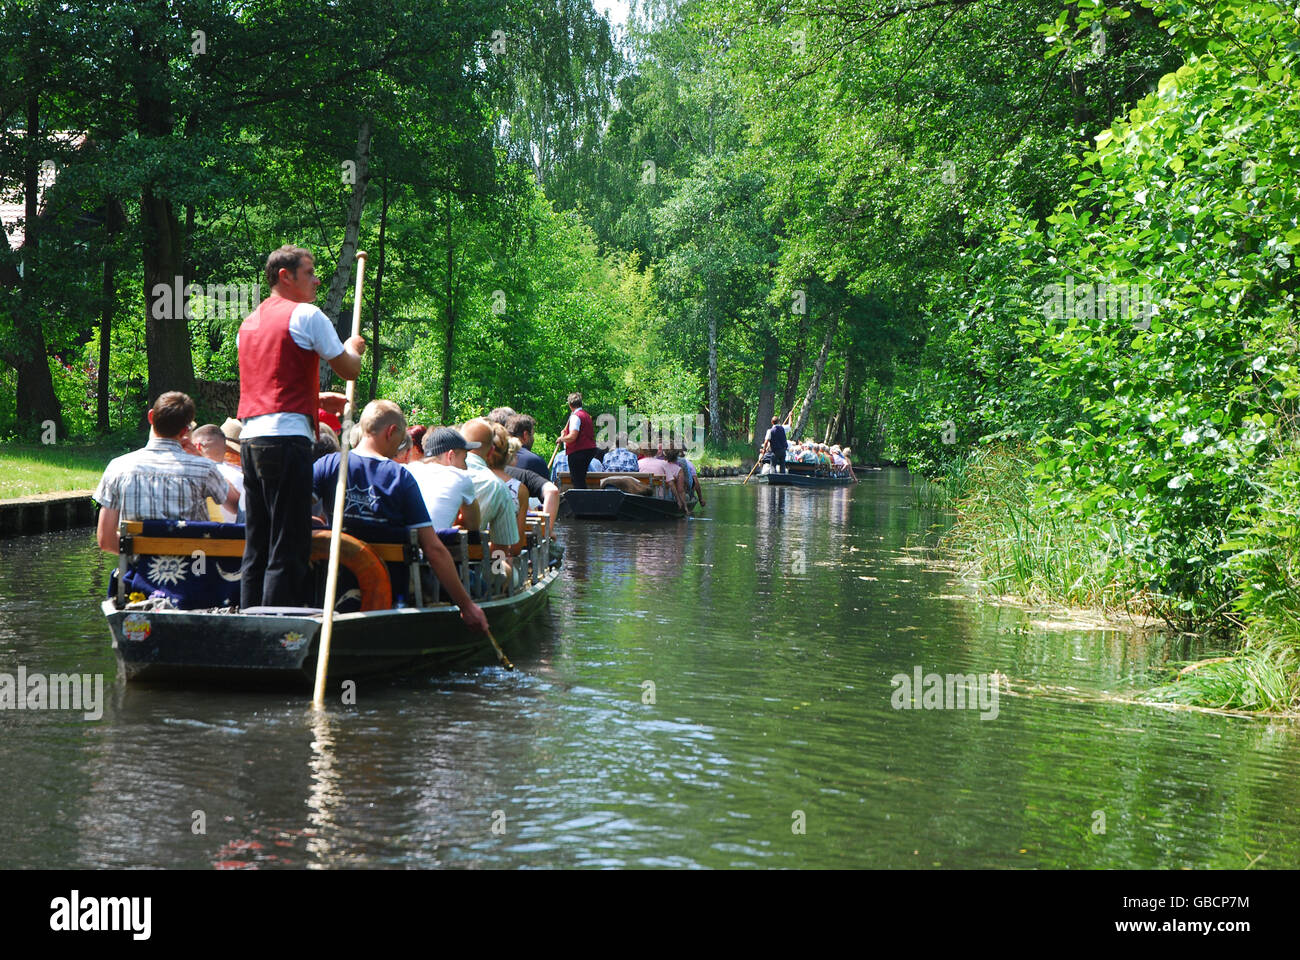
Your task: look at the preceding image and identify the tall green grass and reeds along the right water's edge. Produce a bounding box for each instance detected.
[917,449,1300,713]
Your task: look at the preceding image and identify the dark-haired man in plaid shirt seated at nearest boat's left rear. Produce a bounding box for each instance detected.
[95,390,239,553]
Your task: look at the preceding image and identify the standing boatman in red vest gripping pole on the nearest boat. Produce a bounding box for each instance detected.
[237,243,365,609]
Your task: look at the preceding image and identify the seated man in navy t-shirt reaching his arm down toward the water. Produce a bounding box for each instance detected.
[312,401,488,632]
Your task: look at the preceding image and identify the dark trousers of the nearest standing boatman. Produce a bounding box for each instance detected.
[239,437,312,607]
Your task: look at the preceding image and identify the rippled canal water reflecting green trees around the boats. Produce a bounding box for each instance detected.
[0,471,1300,869]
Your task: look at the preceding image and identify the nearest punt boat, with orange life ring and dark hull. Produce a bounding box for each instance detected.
[103,516,559,691]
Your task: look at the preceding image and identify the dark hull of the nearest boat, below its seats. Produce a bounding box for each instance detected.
[103,570,558,689]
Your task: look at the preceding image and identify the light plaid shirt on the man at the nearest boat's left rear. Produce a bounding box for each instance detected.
[95,437,230,520]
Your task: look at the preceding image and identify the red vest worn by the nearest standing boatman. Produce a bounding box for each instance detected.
[239,294,320,433]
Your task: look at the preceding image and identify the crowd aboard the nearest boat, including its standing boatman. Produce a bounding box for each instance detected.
[95,245,559,631]
